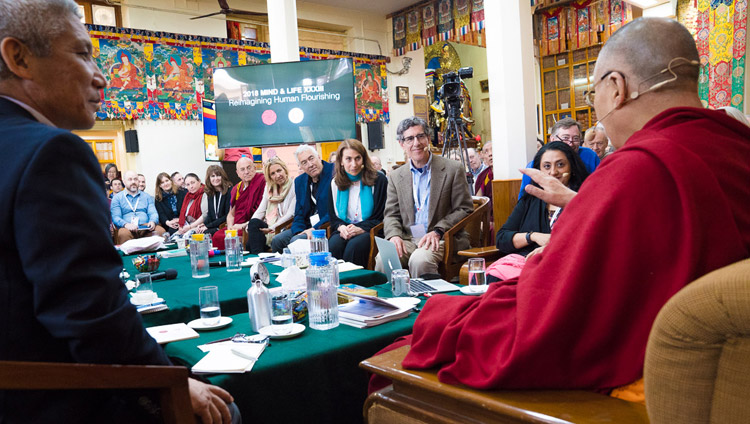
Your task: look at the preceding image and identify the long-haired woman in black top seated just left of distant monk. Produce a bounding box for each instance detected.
[197,165,232,235]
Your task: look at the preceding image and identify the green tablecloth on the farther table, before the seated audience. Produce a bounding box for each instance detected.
[123,256,387,327]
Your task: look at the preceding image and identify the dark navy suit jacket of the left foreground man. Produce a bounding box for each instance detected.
[0,98,170,423]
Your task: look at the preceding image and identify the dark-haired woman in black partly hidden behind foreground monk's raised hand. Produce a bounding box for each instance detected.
[487,141,589,282]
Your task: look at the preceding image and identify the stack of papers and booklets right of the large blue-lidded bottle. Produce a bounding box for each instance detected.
[339,292,414,328]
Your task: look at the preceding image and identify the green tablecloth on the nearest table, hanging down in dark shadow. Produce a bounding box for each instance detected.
[165,285,417,424]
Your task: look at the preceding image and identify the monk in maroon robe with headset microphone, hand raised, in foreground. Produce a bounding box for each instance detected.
[371,18,750,392]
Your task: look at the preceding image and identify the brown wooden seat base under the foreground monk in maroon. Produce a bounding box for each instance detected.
[360,346,649,424]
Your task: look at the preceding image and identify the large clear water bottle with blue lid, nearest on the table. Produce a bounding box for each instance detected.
[305,253,339,330]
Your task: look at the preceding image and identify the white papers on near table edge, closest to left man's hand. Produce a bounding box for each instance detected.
[193,341,266,374]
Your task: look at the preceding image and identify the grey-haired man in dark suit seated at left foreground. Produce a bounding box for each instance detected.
[0,0,231,423]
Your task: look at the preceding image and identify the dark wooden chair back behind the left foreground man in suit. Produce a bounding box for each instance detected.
[0,361,196,424]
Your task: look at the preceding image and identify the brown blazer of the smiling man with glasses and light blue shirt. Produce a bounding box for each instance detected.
[383,154,474,250]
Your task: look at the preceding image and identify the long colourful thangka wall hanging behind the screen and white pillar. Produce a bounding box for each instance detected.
[87,25,389,122]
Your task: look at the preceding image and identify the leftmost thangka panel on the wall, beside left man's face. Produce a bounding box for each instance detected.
[97,40,147,102]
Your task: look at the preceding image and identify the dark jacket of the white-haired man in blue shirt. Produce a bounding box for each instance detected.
[292,161,333,234]
